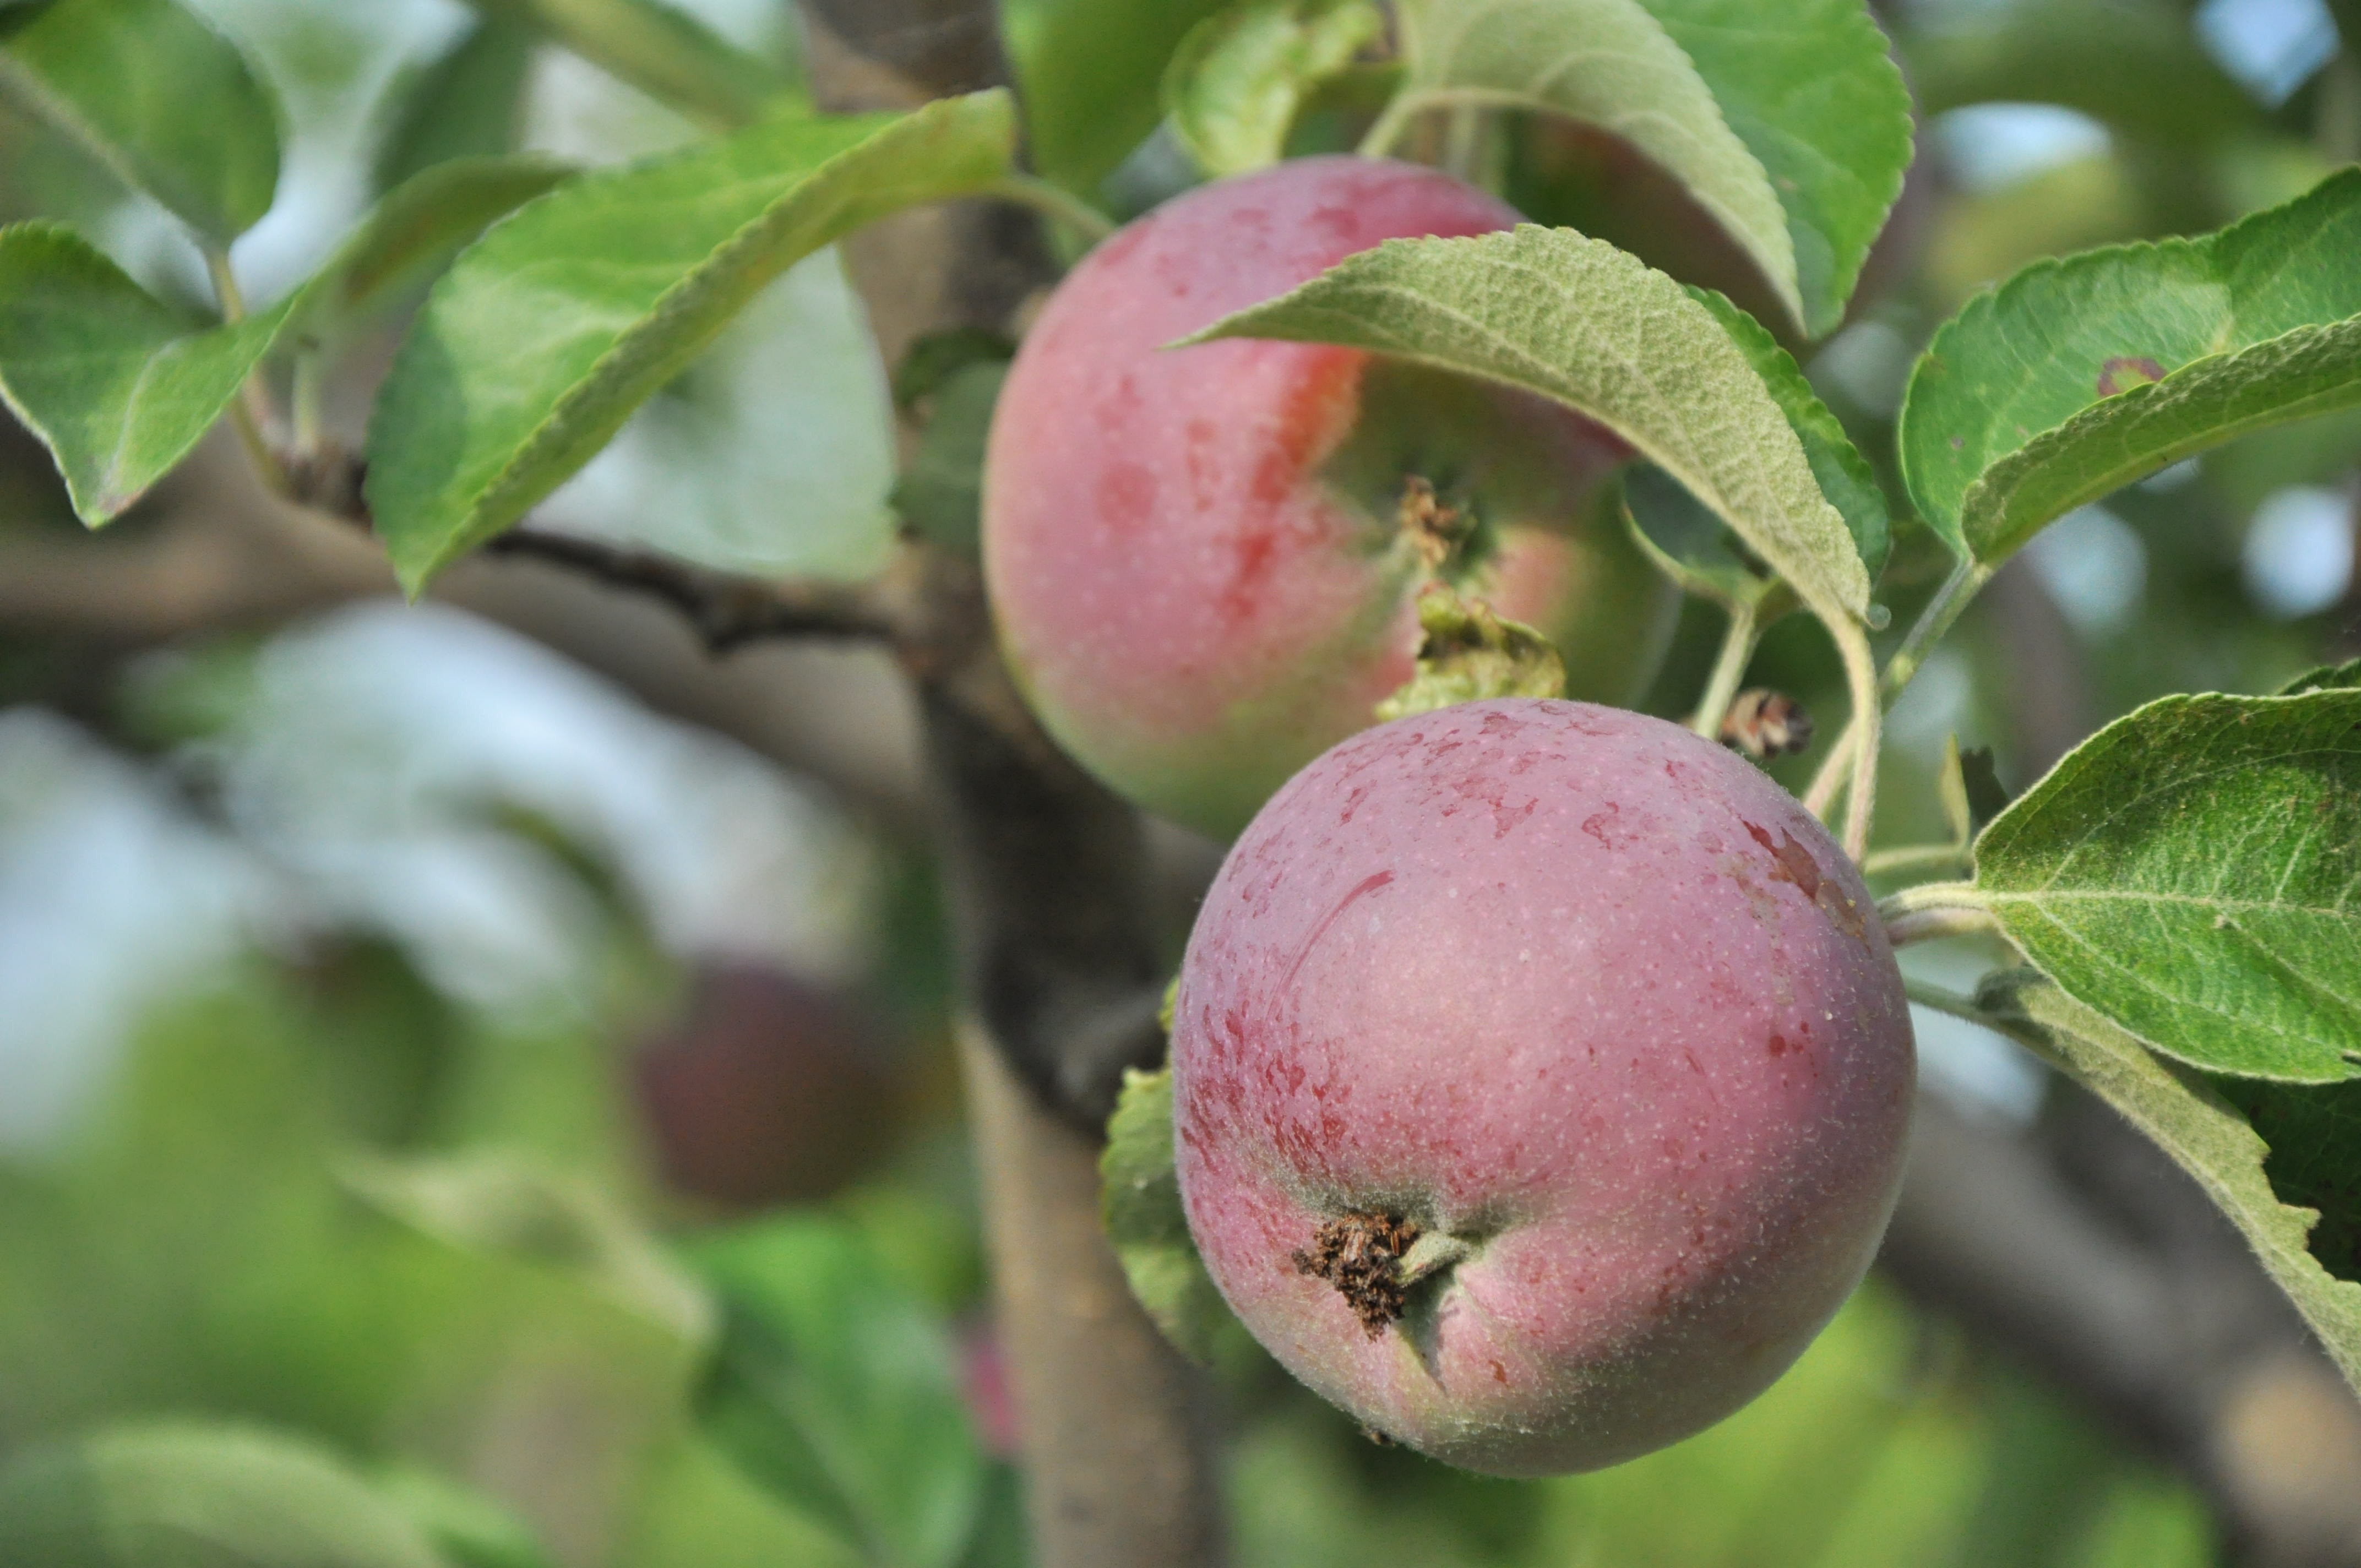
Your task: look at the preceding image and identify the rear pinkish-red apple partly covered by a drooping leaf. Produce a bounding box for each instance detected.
[982,158,1679,839]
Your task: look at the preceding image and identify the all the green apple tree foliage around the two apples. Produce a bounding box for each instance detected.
[0,0,2361,1568]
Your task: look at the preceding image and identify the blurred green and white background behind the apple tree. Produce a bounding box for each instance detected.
[0,0,2361,1568]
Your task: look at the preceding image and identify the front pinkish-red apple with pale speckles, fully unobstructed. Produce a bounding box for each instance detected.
[1173,699,1915,1476]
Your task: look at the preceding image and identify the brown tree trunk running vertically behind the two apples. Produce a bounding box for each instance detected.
[805,0,1223,1568]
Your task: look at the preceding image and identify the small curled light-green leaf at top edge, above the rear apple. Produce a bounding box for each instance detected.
[1164,0,1386,179]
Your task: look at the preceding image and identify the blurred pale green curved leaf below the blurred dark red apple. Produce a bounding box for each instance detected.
[345,1155,713,1344]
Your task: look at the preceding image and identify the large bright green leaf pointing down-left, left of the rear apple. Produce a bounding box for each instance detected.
[368,92,1015,593]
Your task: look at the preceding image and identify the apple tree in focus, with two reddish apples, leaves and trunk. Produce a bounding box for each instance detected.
[0,0,2361,1566]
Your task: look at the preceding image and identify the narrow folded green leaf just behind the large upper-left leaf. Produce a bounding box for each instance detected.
[288,154,574,342]
